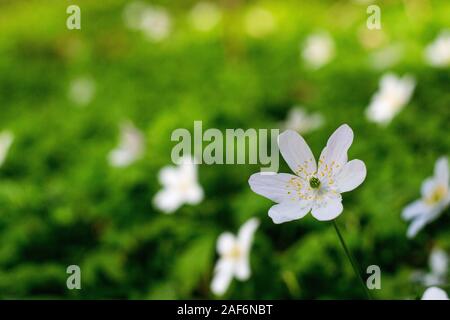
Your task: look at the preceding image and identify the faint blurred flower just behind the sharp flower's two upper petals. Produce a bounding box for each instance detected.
[282,106,324,134]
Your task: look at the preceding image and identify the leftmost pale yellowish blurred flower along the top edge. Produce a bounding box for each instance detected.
[124,1,172,41]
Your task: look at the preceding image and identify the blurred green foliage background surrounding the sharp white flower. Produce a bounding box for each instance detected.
[0,0,450,299]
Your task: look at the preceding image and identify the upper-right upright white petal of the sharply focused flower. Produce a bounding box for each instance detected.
[318,124,353,179]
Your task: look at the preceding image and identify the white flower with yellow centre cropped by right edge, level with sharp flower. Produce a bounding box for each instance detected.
[402,157,450,238]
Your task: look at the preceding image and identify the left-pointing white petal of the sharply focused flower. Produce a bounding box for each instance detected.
[248,173,311,203]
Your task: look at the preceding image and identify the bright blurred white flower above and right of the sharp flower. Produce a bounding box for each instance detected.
[366,73,416,125]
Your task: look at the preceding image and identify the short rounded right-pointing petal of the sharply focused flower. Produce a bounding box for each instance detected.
[335,160,367,192]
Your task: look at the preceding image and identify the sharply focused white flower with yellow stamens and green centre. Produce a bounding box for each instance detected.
[249,124,366,223]
